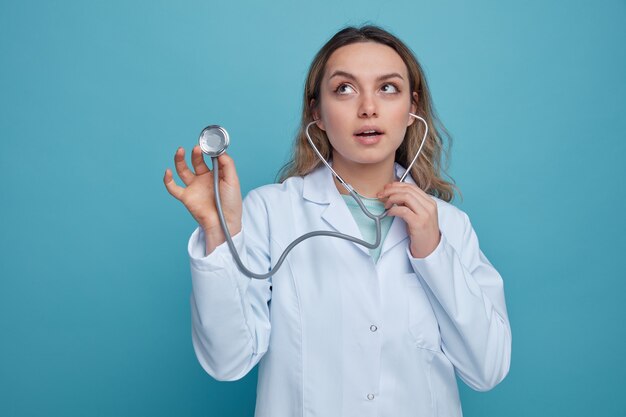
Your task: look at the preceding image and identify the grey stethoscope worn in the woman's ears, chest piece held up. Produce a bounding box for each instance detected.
[198,113,428,279]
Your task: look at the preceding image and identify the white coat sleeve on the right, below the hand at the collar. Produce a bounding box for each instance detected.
[409,211,511,391]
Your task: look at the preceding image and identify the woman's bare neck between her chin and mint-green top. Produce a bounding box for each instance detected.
[333,156,396,198]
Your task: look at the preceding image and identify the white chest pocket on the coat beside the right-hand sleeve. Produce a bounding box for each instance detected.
[405,273,441,352]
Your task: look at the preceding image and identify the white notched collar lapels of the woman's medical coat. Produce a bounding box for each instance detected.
[302,164,415,256]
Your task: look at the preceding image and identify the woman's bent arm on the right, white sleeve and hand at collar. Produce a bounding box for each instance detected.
[379,182,511,391]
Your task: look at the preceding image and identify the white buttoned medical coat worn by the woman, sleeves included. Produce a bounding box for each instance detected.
[188,162,511,417]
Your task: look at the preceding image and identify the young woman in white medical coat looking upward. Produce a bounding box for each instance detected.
[164,26,511,417]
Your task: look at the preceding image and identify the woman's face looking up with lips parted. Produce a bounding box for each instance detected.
[314,42,417,171]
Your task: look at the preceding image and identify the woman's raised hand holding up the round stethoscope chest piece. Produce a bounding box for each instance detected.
[163,145,241,254]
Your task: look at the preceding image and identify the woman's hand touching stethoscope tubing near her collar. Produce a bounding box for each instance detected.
[377,182,441,258]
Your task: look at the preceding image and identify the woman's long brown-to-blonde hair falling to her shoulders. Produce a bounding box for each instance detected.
[279,25,458,201]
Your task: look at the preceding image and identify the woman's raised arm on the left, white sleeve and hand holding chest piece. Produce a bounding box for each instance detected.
[163,146,271,380]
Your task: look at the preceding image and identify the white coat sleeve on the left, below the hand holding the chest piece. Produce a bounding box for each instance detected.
[188,191,271,381]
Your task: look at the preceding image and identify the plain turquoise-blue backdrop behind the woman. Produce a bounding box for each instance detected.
[0,0,626,416]
